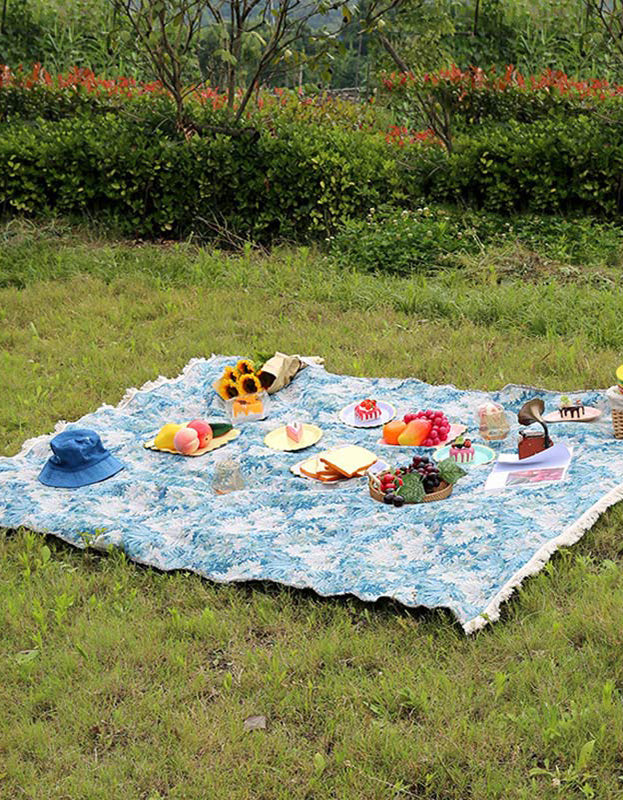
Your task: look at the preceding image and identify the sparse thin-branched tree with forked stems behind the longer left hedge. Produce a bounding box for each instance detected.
[110,0,405,127]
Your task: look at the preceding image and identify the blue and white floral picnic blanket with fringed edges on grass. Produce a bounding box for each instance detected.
[0,356,623,632]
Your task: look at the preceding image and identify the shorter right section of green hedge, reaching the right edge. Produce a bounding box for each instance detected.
[414,116,623,217]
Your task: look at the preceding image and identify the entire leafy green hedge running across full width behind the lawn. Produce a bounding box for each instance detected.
[0,106,623,242]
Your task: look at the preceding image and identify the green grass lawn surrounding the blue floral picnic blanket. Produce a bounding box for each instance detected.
[0,220,623,800]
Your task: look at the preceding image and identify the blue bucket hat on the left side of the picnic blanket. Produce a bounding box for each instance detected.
[39,428,123,489]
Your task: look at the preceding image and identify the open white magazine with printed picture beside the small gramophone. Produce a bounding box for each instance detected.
[485,443,573,492]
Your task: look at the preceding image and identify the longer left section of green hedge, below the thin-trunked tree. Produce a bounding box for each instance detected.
[0,113,407,241]
